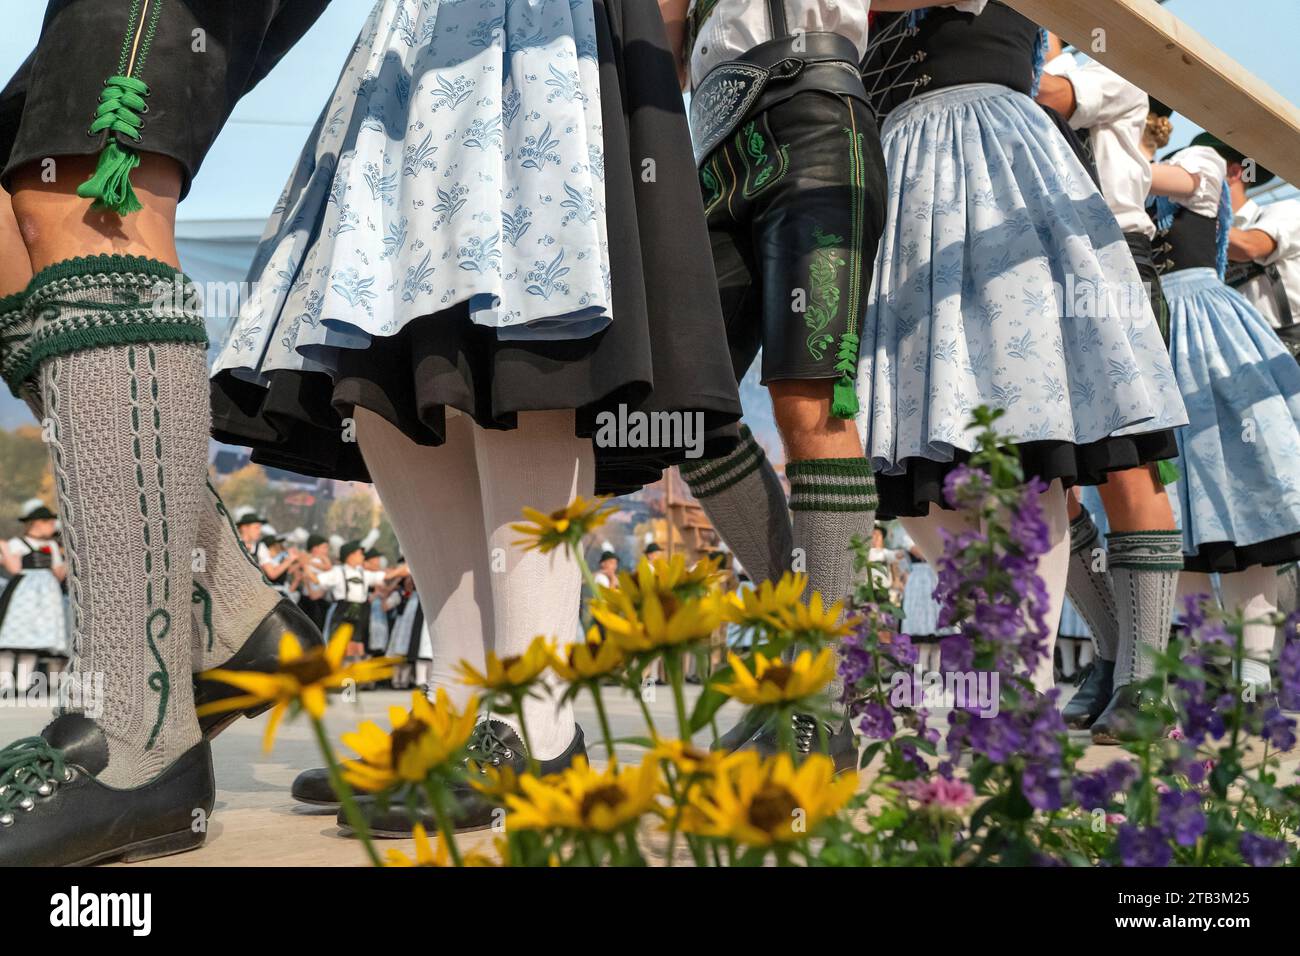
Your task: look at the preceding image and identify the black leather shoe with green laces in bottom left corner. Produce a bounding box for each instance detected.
[0,714,217,866]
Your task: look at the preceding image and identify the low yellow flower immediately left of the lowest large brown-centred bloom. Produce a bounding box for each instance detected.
[506,754,660,834]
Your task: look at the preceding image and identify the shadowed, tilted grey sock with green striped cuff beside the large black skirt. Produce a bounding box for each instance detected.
[680,425,794,584]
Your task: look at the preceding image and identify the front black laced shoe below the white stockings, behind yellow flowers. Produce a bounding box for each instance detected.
[338,719,586,840]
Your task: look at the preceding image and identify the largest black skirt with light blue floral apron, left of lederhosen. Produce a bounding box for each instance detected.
[213,0,741,492]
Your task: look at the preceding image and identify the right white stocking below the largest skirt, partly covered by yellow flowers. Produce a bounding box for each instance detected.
[475,411,595,760]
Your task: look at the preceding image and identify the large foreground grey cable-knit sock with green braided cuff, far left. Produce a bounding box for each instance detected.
[22,256,209,787]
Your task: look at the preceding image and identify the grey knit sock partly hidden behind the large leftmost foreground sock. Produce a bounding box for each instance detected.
[191,480,281,671]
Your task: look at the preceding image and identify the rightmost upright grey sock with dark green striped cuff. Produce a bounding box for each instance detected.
[1106,531,1183,688]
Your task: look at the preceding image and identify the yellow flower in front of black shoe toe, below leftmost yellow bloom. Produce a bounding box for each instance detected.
[343,687,478,793]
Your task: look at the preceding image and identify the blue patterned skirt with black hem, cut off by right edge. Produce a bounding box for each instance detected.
[1161,268,1300,572]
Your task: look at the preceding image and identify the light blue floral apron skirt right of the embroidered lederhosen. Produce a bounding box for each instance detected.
[858,83,1187,515]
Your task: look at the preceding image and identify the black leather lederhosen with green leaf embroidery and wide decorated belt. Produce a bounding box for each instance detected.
[690,0,885,418]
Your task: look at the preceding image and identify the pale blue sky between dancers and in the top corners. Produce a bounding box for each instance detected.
[0,0,1300,220]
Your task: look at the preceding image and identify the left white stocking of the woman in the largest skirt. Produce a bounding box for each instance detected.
[356,408,491,705]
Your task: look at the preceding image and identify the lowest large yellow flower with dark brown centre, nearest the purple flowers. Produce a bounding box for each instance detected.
[677,752,858,847]
